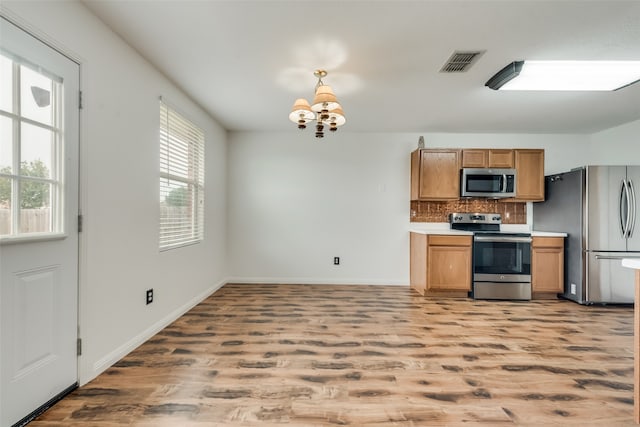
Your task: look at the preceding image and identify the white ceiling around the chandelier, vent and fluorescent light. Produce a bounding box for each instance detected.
[83,0,640,133]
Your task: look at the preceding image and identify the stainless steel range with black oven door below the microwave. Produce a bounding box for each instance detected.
[449,213,531,300]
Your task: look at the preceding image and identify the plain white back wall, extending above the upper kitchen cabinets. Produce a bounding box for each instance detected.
[228,130,590,285]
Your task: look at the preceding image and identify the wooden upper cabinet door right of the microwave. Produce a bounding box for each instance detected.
[514,149,544,202]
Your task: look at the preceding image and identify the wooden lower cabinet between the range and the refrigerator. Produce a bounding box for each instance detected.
[531,236,564,299]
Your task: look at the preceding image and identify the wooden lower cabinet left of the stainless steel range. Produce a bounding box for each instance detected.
[410,233,472,297]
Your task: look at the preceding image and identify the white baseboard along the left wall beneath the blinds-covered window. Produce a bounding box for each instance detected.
[85,279,229,385]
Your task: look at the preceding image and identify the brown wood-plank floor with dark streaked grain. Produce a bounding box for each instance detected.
[30,284,635,427]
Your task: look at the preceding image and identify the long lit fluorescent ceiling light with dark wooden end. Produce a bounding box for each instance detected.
[485,61,640,91]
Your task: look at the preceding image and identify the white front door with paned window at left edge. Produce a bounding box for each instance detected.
[0,17,79,426]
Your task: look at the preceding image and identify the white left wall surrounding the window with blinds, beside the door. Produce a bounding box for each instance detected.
[2,1,227,383]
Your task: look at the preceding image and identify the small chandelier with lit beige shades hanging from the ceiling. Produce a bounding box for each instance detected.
[289,70,347,138]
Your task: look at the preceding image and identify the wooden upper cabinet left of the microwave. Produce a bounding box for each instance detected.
[411,149,462,200]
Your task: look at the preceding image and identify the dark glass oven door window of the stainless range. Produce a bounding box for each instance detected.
[473,242,531,275]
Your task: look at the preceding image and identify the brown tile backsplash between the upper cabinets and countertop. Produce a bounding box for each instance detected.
[410,199,527,224]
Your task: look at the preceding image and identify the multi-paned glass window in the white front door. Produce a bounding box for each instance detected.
[0,52,64,237]
